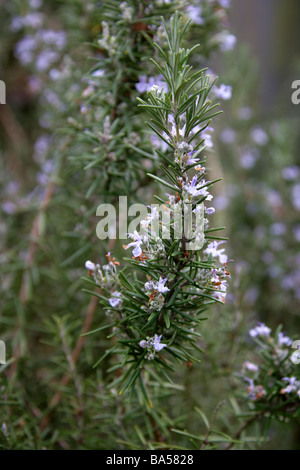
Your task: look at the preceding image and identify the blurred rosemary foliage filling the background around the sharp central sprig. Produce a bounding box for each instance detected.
[0,0,300,449]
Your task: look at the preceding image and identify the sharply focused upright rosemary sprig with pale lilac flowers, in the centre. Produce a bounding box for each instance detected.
[86,14,229,394]
